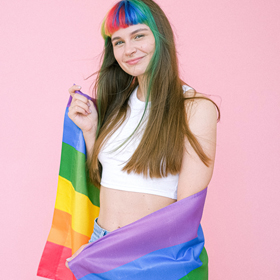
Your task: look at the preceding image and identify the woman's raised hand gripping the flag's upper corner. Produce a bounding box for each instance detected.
[68,85,98,134]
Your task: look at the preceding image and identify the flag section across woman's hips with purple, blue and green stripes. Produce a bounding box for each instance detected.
[69,189,208,280]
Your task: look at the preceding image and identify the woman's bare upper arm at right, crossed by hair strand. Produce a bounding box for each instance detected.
[177,94,217,200]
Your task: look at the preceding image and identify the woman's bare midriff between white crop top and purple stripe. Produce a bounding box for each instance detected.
[98,186,176,231]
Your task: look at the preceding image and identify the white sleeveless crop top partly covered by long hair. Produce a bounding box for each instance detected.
[98,85,191,199]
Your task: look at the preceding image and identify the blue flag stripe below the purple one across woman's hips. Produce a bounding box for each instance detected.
[79,225,204,280]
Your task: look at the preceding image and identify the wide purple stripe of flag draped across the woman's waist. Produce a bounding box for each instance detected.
[69,188,207,279]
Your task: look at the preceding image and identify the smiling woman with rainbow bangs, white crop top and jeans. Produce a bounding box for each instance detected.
[66,0,217,276]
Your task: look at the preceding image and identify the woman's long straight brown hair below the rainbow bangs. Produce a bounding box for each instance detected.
[88,0,219,187]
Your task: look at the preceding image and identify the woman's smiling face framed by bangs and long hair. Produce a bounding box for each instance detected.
[111,24,155,78]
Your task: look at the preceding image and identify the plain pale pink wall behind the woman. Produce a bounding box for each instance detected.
[0,0,280,280]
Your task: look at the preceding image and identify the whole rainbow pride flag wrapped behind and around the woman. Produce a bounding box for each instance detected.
[38,93,208,280]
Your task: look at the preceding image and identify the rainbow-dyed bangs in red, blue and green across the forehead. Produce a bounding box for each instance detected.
[101,0,152,39]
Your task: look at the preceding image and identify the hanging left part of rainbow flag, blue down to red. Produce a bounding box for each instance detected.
[37,92,99,280]
